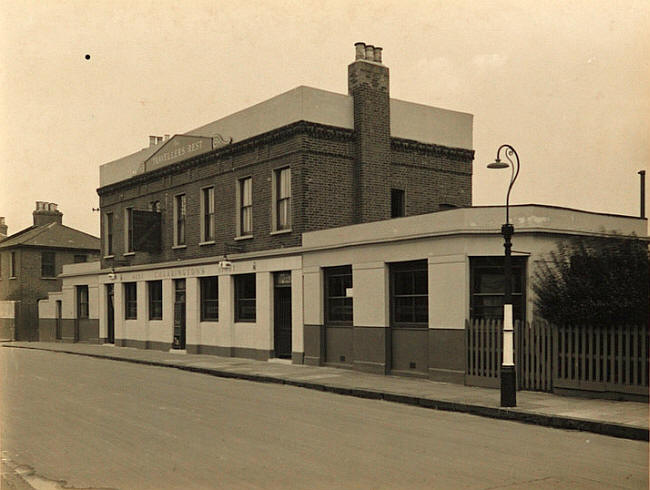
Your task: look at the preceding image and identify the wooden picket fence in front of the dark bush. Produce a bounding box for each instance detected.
[465,320,650,396]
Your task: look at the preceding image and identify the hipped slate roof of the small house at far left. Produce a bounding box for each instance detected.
[0,222,101,251]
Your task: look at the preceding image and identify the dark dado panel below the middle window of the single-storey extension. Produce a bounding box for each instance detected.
[390,328,429,376]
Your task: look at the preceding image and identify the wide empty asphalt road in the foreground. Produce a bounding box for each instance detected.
[0,348,648,489]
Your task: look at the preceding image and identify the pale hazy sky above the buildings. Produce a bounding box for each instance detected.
[0,0,650,236]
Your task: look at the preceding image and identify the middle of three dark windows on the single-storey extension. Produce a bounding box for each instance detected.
[390,260,429,327]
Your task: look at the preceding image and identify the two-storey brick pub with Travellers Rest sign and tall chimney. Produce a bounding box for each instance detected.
[86,43,473,362]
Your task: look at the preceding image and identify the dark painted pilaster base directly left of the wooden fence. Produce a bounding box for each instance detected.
[429,328,465,384]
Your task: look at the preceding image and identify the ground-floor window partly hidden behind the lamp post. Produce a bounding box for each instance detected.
[470,257,526,321]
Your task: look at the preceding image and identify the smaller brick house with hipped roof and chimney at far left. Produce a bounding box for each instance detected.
[0,201,99,340]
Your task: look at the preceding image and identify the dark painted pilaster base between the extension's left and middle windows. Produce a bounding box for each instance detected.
[353,326,391,374]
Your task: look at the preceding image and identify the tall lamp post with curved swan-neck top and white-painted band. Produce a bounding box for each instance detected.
[488,145,519,407]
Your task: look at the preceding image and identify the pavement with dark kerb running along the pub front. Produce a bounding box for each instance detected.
[2,342,648,441]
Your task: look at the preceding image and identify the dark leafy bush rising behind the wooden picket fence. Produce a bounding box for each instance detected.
[533,236,650,326]
